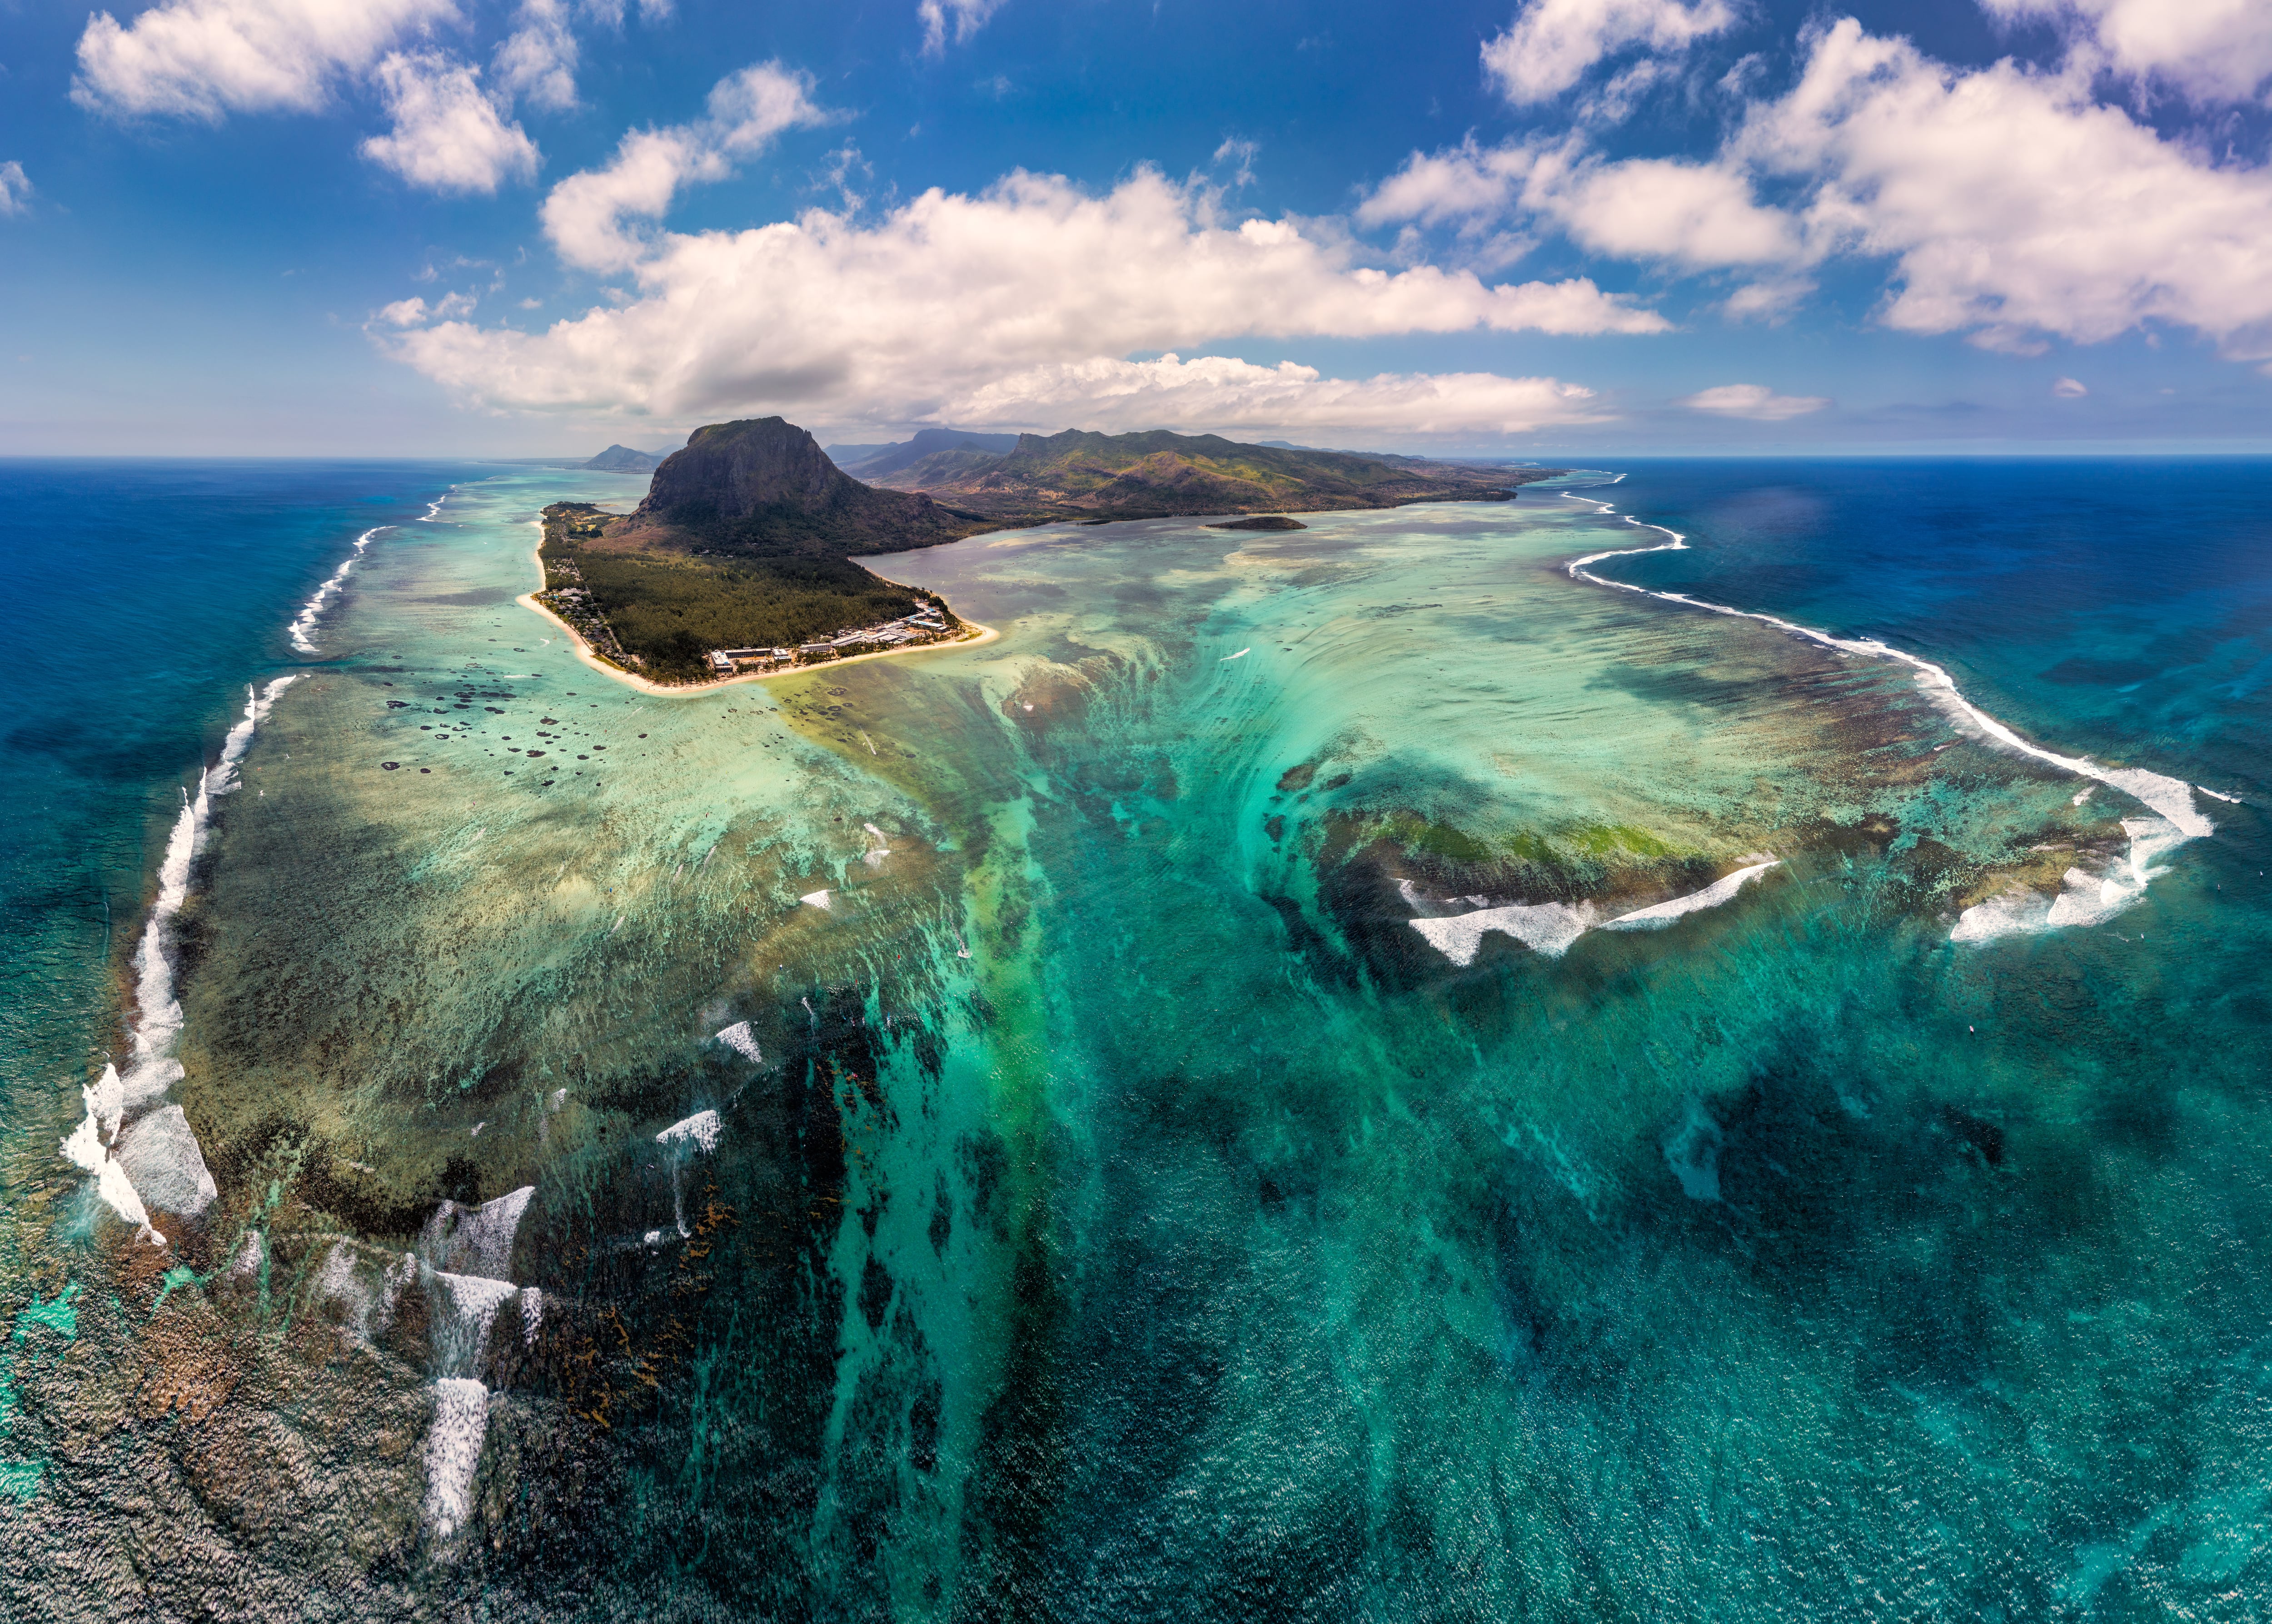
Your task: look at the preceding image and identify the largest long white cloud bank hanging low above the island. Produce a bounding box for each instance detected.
[393,164,1668,436]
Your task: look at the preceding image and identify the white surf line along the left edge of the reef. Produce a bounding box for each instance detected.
[61,672,300,1245]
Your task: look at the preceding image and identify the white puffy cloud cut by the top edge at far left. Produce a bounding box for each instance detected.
[70,0,457,118]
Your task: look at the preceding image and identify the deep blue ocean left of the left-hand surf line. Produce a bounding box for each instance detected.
[0,459,482,1136]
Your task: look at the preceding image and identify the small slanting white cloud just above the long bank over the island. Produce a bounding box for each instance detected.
[543,61,829,270]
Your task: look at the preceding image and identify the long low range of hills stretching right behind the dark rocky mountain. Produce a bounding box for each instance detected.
[866,429,1552,522]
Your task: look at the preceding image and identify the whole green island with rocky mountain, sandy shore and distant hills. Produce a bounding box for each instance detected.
[532,418,1556,686]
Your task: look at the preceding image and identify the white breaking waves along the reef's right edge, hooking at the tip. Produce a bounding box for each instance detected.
[1563,491,2233,943]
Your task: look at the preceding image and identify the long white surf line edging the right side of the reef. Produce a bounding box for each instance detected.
[1568,497,2231,940]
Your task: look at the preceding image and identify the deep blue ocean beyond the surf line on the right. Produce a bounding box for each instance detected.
[1604,459,2272,804]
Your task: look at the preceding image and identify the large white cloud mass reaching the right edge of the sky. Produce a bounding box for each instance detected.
[1356,19,2272,359]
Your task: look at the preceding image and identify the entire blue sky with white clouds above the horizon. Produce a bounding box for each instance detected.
[0,0,2272,459]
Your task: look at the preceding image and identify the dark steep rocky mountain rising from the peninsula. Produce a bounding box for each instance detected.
[632,418,991,556]
